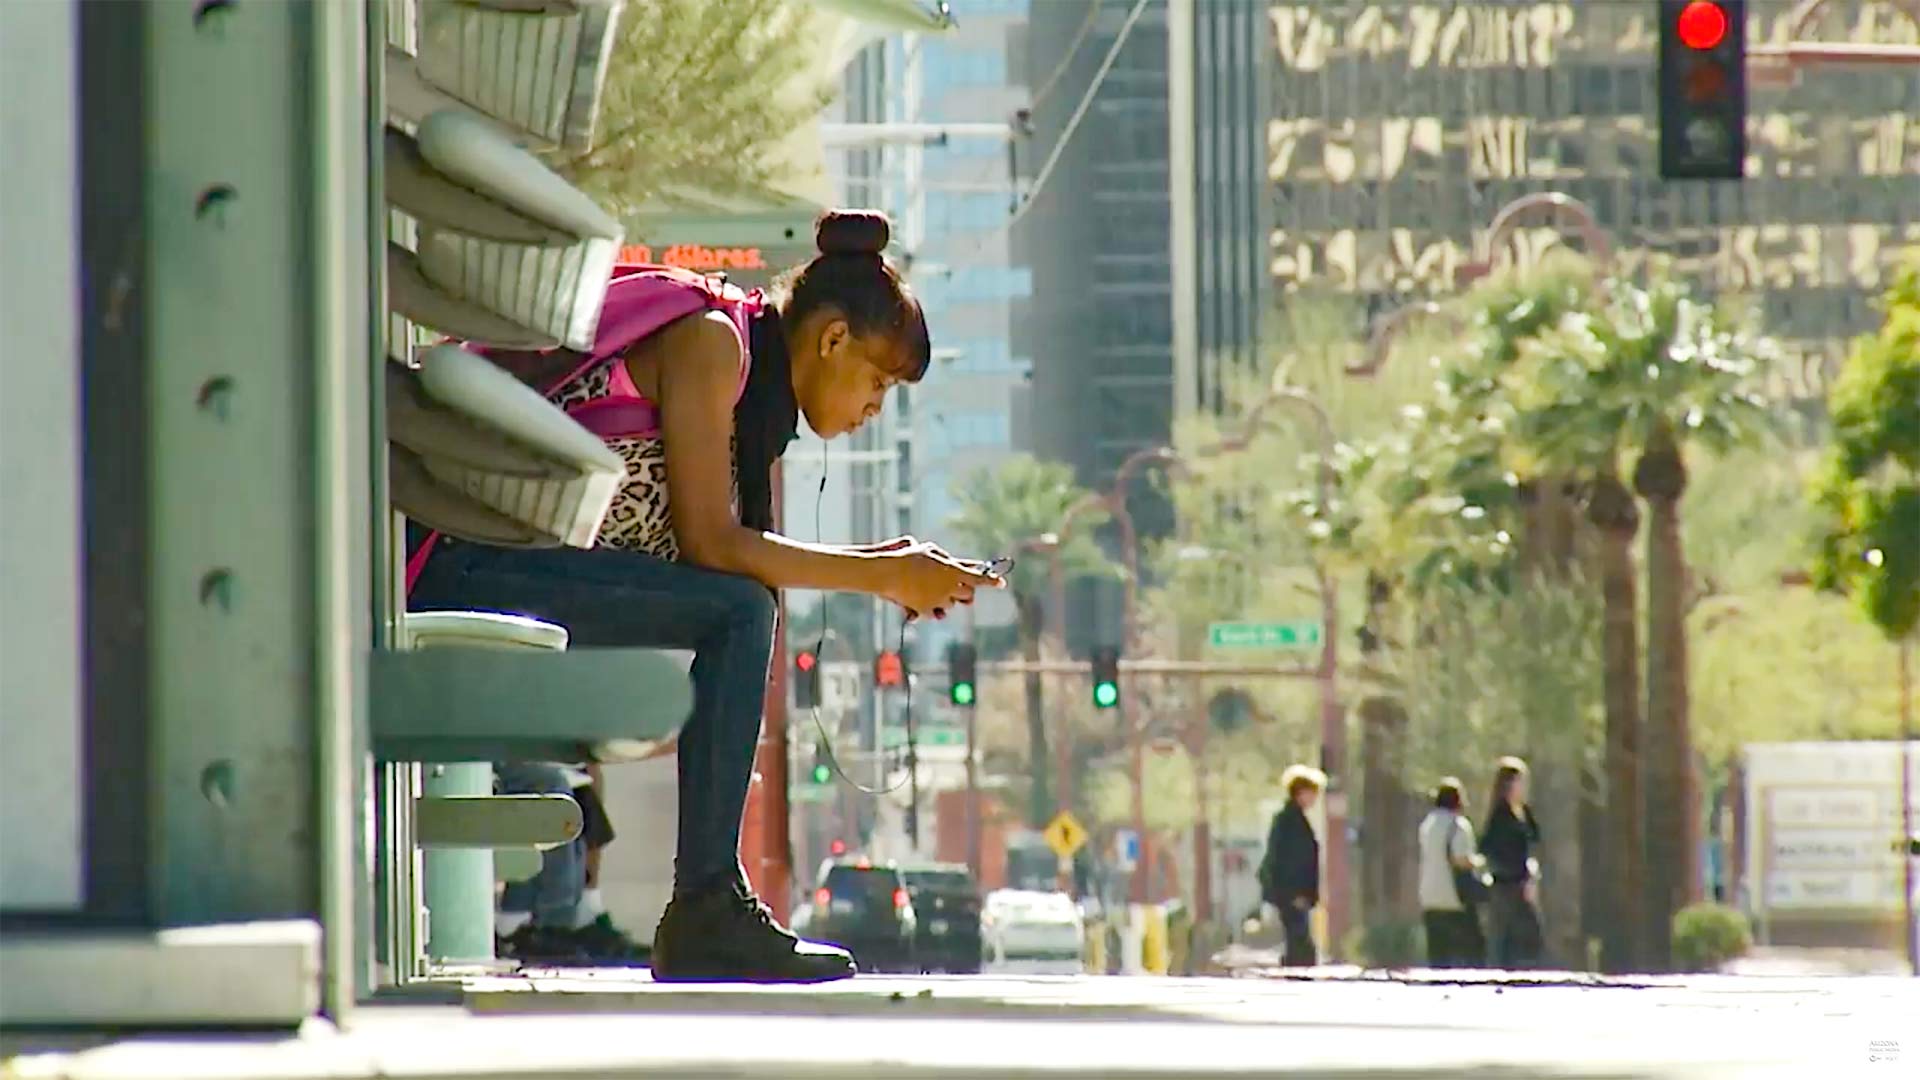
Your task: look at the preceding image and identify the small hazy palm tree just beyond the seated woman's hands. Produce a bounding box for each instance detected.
[950,454,1116,828]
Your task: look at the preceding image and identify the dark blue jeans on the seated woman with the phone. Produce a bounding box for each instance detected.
[407,538,778,894]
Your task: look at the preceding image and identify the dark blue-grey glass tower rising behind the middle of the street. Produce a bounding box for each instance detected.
[1014,0,1271,651]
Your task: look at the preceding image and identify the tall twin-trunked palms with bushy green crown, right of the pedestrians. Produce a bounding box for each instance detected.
[1515,281,1772,965]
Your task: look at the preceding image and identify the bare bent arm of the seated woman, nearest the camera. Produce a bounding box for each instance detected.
[647,313,995,601]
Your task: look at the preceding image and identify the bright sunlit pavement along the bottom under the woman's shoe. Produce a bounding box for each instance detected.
[0,970,1920,1080]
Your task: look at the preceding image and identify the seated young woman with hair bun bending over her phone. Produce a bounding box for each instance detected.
[409,211,1000,982]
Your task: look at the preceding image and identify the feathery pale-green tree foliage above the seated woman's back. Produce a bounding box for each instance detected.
[549,0,833,215]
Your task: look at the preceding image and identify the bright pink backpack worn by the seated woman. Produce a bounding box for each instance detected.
[407,263,766,592]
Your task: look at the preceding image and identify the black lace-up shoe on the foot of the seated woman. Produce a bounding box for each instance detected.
[653,884,854,982]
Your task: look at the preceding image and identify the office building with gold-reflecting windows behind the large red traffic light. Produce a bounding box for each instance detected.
[1267,0,1920,396]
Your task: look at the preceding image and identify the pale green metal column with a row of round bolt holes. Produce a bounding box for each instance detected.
[142,0,371,1015]
